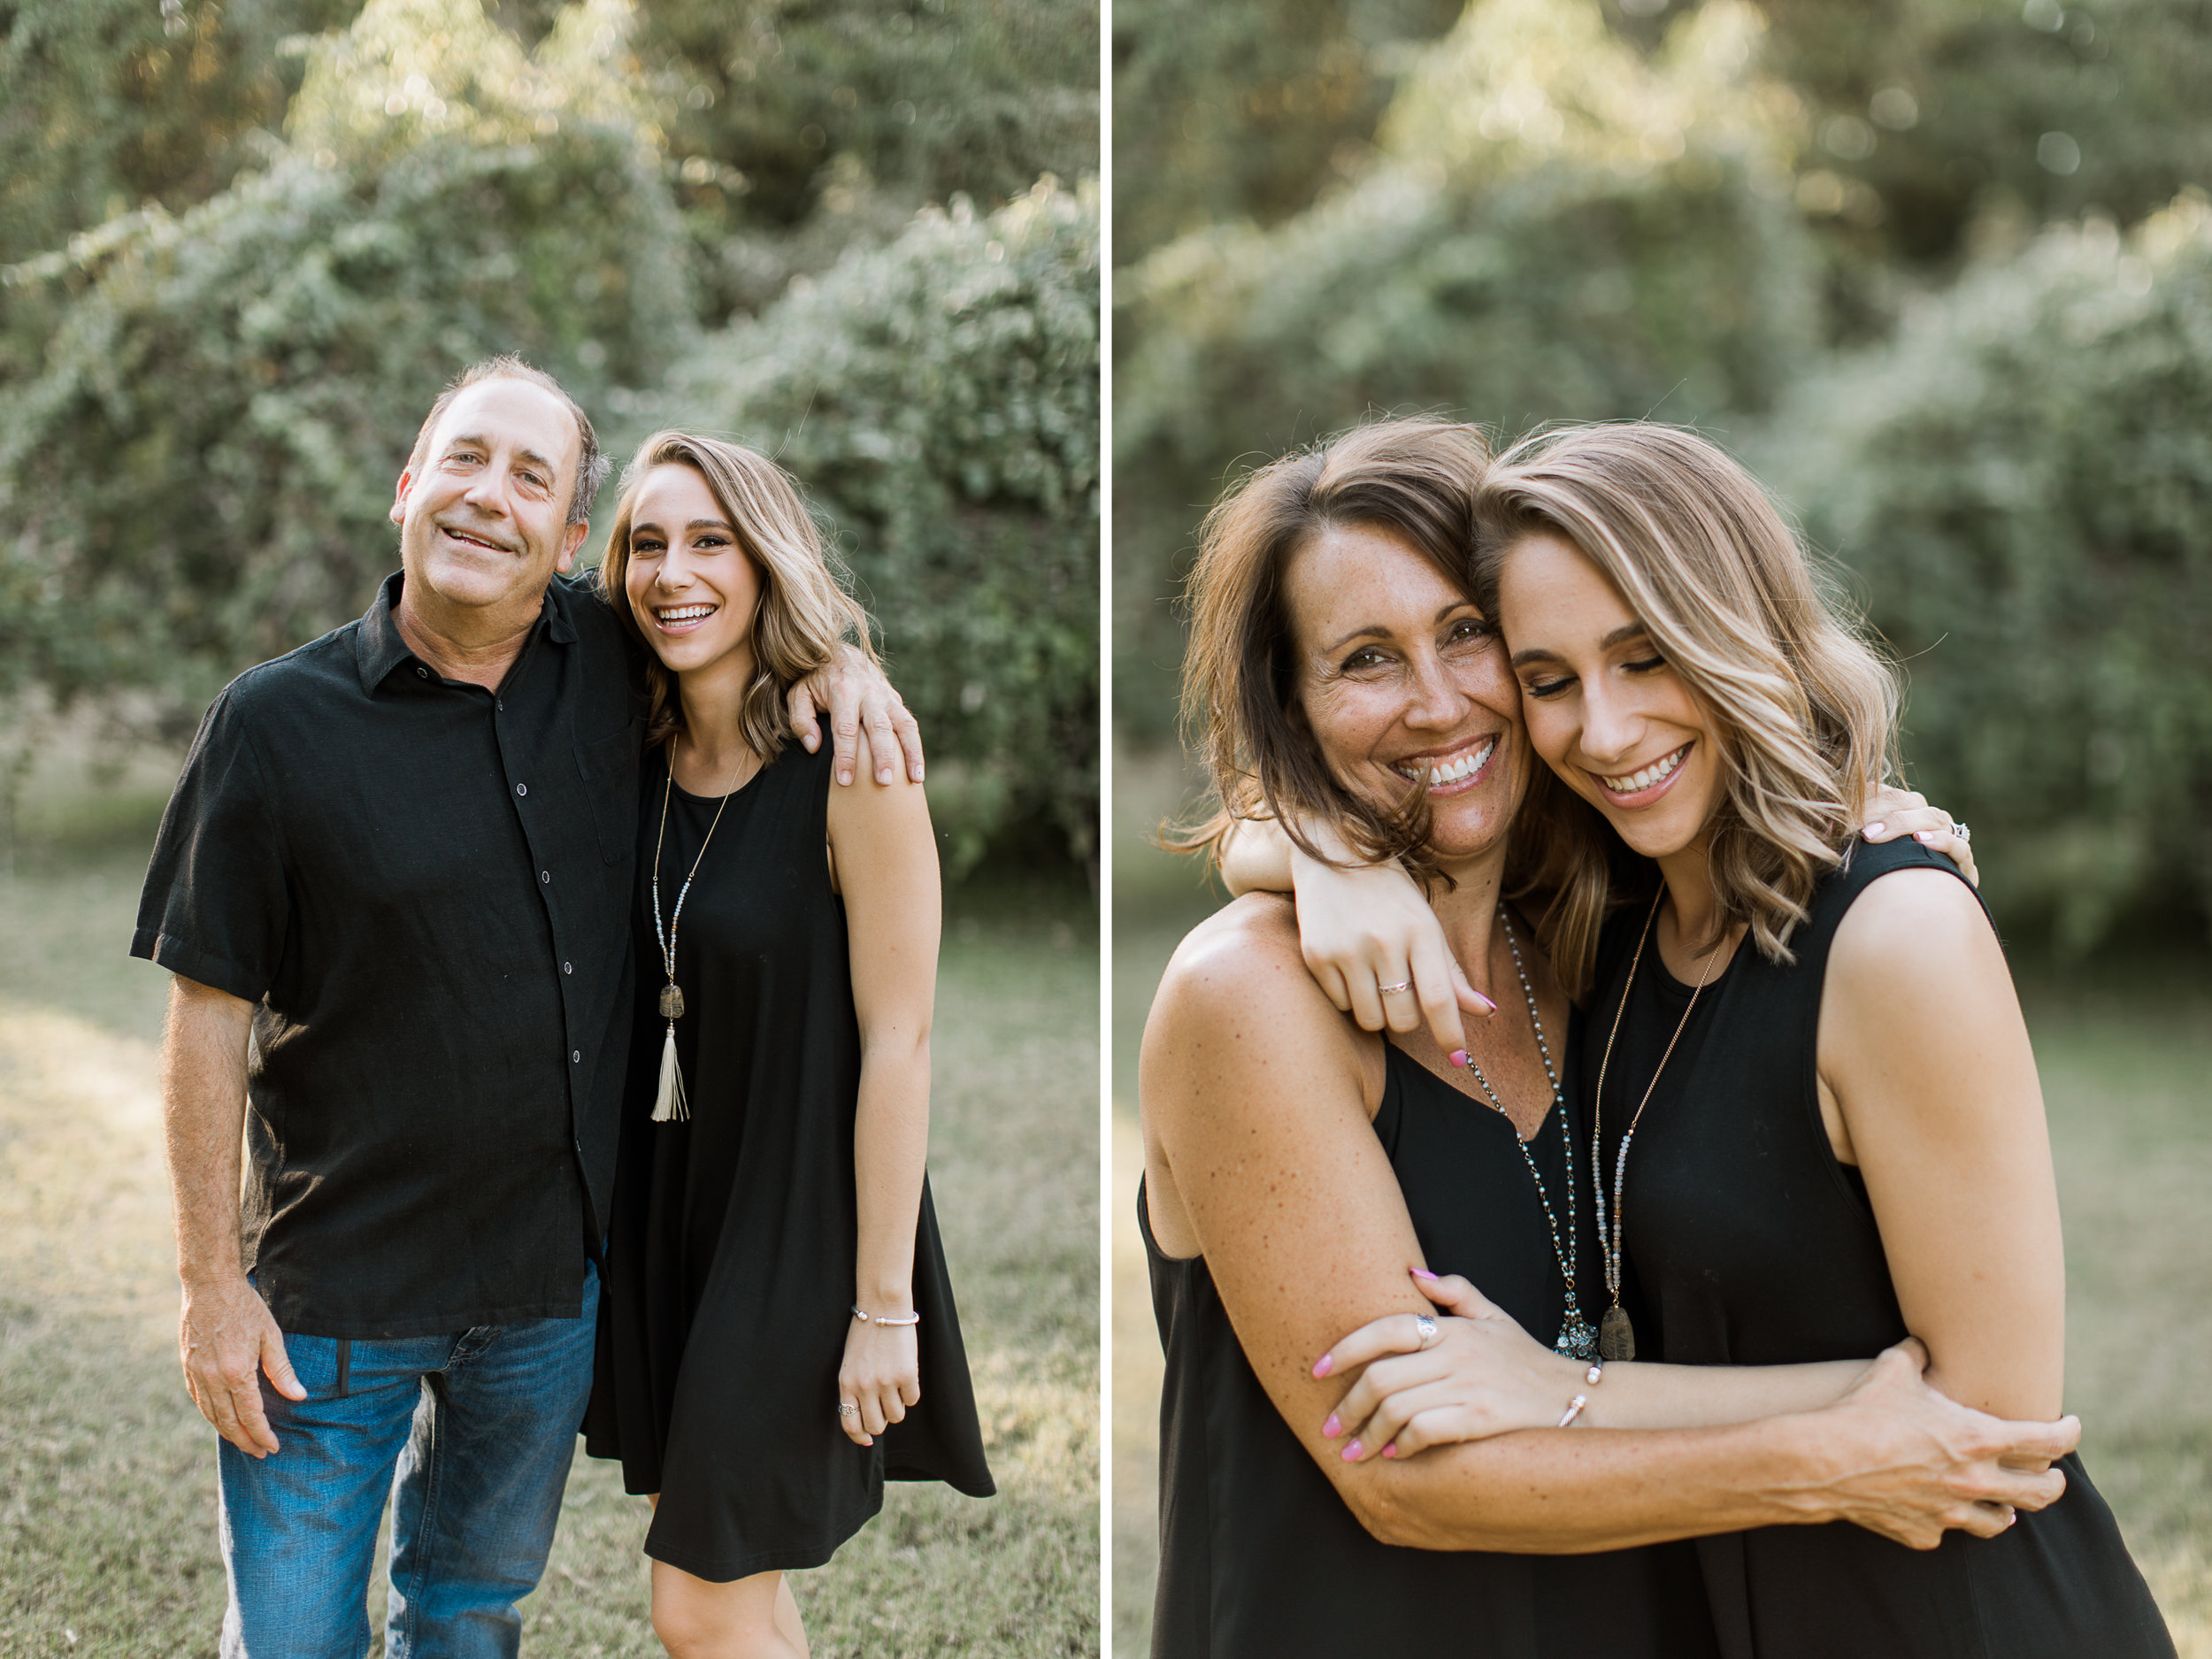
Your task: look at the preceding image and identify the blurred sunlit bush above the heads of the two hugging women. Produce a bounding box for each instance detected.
[1115,0,1818,733]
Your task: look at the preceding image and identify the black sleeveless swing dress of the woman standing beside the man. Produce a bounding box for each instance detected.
[584,743,994,1584]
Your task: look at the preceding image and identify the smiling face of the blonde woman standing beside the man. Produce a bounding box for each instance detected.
[622,463,761,675]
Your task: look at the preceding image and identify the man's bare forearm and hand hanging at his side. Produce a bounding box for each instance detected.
[162,973,308,1458]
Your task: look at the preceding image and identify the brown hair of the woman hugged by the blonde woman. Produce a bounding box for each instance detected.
[1166,419,1491,879]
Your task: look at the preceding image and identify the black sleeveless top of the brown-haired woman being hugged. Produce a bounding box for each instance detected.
[1137,1040,1717,1659]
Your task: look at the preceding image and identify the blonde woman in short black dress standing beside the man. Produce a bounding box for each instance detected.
[587,432,991,1659]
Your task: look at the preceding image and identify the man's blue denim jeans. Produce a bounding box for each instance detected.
[219,1268,600,1659]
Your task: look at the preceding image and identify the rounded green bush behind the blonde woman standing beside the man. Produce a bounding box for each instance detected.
[659,180,1100,874]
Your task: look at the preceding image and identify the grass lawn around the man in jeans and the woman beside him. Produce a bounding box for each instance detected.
[0,761,1100,1659]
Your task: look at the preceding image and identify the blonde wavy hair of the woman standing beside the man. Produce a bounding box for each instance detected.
[600,432,876,764]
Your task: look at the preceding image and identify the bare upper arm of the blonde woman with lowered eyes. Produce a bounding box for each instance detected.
[1818,870,2066,1418]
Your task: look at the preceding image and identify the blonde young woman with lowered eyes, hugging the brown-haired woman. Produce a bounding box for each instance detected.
[1256,425,2172,1659]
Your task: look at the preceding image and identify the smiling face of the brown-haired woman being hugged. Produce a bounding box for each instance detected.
[1283,525,1529,861]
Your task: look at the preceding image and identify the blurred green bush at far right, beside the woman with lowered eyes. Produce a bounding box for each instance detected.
[1755,195,2212,951]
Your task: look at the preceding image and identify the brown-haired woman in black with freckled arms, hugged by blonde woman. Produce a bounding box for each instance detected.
[1140,420,2075,1659]
